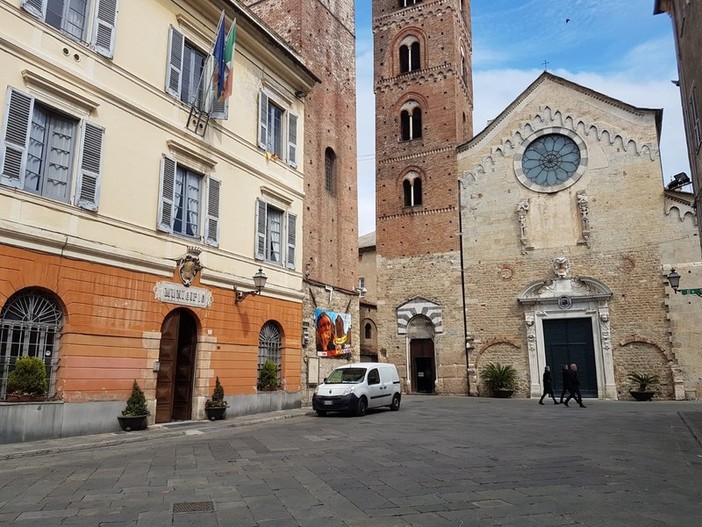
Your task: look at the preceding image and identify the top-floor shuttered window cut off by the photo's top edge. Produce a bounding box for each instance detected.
[22,0,118,57]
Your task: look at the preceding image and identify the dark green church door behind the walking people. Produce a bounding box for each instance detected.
[543,318,597,397]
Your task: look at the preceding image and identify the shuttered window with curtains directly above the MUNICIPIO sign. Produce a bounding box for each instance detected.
[158,156,220,245]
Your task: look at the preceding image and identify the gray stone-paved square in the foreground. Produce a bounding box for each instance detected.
[0,396,702,527]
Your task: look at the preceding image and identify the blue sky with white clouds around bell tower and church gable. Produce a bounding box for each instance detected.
[355,0,690,235]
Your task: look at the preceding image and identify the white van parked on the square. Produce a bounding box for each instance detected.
[312,362,402,416]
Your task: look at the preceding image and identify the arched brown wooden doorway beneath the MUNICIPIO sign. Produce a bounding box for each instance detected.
[156,308,197,423]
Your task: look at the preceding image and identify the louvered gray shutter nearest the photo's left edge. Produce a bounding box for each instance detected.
[0,88,34,188]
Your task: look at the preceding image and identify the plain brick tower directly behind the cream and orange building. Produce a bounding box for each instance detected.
[242,0,360,392]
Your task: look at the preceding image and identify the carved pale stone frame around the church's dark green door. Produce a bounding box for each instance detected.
[518,257,617,400]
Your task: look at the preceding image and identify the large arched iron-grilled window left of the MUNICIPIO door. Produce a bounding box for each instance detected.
[0,289,63,398]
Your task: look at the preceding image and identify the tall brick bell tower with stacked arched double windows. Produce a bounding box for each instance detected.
[373,0,473,394]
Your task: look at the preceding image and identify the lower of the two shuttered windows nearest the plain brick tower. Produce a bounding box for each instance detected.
[255,199,297,269]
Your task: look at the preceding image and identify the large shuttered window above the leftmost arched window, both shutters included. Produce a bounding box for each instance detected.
[0,89,103,210]
